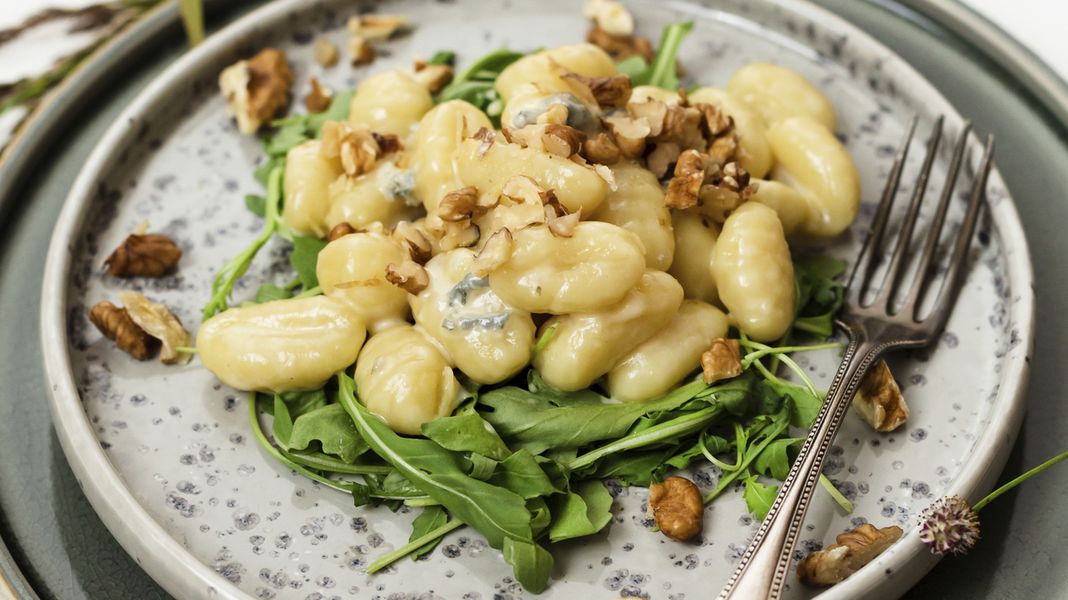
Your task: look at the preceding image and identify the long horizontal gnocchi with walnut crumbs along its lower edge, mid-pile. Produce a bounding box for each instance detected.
[456,137,608,215]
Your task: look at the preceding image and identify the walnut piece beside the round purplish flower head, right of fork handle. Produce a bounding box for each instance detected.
[798,523,902,586]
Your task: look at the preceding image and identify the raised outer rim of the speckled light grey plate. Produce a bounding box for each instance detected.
[41,0,1035,600]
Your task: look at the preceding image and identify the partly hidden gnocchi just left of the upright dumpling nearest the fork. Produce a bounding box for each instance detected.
[668,209,720,304]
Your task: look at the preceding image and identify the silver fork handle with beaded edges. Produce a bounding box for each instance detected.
[720,328,886,600]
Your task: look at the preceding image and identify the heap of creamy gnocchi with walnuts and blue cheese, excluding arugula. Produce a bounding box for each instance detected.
[198,44,860,435]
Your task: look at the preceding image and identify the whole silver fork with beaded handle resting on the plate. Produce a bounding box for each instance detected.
[720,116,993,600]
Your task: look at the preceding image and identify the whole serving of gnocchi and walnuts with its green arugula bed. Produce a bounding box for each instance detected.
[197,8,875,593]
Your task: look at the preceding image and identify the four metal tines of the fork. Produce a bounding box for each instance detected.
[848,116,993,329]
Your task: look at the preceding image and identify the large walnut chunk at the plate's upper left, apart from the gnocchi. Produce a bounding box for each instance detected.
[219,48,293,133]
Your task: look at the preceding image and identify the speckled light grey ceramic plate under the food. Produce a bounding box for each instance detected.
[42,0,1034,599]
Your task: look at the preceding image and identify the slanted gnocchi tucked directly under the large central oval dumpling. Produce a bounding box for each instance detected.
[533,270,682,392]
